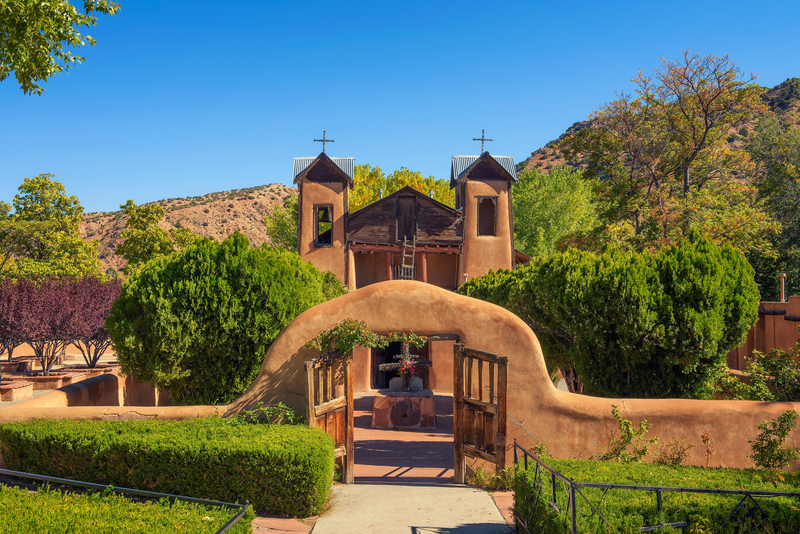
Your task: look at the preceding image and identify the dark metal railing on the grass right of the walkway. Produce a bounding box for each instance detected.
[514,439,800,534]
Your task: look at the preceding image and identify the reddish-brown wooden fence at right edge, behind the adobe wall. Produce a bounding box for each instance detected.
[728,295,800,371]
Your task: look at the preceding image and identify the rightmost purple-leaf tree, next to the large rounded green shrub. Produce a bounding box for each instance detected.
[70,278,122,368]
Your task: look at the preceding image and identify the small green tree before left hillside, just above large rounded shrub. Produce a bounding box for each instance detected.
[116,200,199,274]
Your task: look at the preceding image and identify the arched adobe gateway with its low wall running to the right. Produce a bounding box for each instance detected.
[228,281,800,467]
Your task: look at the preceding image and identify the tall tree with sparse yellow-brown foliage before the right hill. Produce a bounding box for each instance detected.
[562,51,775,255]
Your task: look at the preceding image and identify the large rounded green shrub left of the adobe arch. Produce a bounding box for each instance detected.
[107,233,341,404]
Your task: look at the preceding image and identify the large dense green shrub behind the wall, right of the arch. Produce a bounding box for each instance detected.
[458,233,759,398]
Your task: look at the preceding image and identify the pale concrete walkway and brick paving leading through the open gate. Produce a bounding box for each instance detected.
[260,393,513,534]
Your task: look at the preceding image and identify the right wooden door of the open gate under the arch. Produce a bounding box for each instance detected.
[453,343,508,484]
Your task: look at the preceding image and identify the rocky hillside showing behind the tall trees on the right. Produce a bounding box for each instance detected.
[517,78,800,172]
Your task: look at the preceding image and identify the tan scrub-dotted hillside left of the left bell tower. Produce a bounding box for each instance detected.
[81,184,297,271]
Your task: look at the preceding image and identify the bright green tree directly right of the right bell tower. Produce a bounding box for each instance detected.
[511,166,597,256]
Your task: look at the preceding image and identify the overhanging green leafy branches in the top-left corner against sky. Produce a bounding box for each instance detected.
[0,0,119,95]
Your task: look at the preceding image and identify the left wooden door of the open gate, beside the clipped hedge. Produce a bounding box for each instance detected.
[305,351,354,484]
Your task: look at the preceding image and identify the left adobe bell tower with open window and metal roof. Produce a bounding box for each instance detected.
[294,152,355,284]
